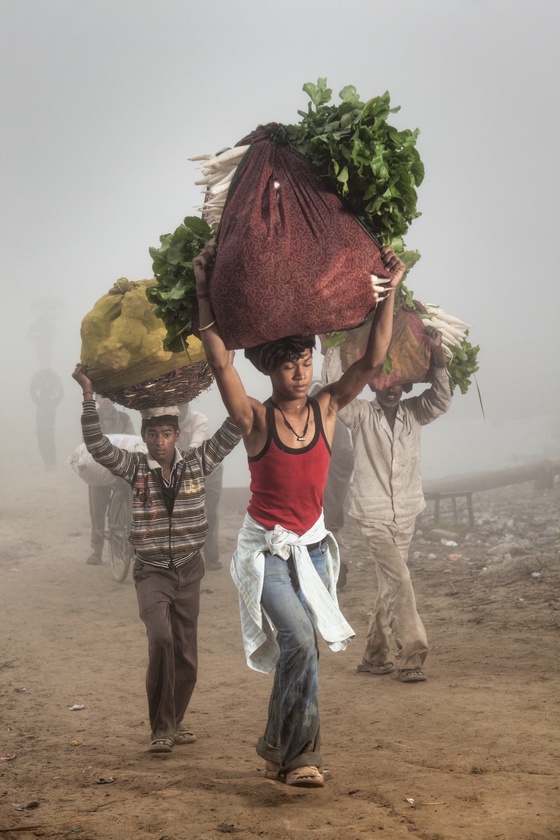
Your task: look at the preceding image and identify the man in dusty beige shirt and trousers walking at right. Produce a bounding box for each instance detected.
[323,327,453,683]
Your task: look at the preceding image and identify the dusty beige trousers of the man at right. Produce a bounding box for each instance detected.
[360,517,428,670]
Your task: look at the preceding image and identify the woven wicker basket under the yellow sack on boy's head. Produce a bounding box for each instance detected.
[97,360,214,411]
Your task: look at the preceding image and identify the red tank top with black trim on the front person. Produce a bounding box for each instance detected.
[247,397,331,536]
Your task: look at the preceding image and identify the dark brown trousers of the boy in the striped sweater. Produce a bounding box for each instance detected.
[134,553,204,738]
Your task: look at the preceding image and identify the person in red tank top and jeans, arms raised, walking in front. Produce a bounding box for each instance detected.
[193,242,404,787]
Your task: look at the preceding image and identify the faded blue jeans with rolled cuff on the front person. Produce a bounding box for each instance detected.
[257,543,327,773]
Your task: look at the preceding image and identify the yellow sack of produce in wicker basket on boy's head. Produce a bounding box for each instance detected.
[77,278,212,409]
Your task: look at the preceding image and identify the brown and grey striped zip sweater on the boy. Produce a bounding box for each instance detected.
[82,400,241,568]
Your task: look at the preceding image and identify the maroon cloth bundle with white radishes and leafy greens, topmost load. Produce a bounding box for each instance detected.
[150,79,424,349]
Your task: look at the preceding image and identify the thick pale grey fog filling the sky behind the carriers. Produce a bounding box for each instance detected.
[0,0,560,486]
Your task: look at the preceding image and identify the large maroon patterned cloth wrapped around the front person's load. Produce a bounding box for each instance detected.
[209,139,396,349]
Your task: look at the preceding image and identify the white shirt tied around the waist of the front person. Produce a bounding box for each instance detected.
[230,514,355,673]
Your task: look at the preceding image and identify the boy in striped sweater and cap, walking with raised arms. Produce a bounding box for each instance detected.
[73,364,241,753]
